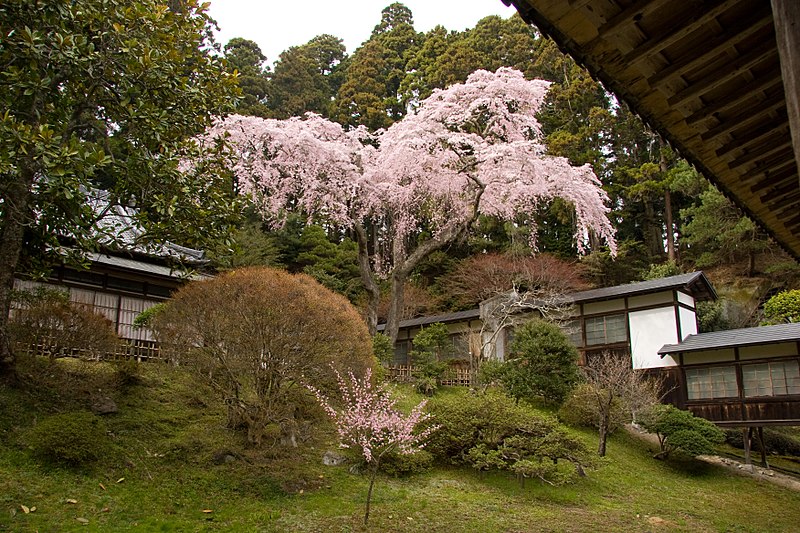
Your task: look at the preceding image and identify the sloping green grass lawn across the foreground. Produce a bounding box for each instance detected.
[0,360,800,533]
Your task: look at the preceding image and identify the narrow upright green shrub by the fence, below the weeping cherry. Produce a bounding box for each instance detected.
[411,322,453,396]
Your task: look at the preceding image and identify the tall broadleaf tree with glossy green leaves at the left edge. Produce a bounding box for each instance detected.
[0,0,237,372]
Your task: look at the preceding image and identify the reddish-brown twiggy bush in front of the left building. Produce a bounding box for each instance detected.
[9,287,120,359]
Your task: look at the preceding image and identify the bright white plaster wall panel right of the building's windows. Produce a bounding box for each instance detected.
[628,307,678,368]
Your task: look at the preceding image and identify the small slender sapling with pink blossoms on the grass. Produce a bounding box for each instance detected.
[306,369,437,525]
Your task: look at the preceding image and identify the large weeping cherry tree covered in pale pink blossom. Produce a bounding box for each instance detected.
[206,68,616,341]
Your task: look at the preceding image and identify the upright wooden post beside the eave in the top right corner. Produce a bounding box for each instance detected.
[772,0,800,185]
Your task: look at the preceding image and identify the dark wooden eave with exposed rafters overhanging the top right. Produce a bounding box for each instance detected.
[503,0,800,259]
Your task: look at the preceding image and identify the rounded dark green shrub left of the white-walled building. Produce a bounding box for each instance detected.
[501,319,579,403]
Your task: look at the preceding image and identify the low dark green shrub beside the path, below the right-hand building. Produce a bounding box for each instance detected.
[639,405,725,459]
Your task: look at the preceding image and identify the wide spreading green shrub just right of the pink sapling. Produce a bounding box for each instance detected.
[426,390,595,484]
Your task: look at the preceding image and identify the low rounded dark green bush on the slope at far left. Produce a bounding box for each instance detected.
[26,411,110,466]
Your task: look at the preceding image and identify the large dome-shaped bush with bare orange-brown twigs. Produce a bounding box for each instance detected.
[153,267,375,444]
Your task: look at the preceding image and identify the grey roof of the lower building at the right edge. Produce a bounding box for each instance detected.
[658,323,800,356]
